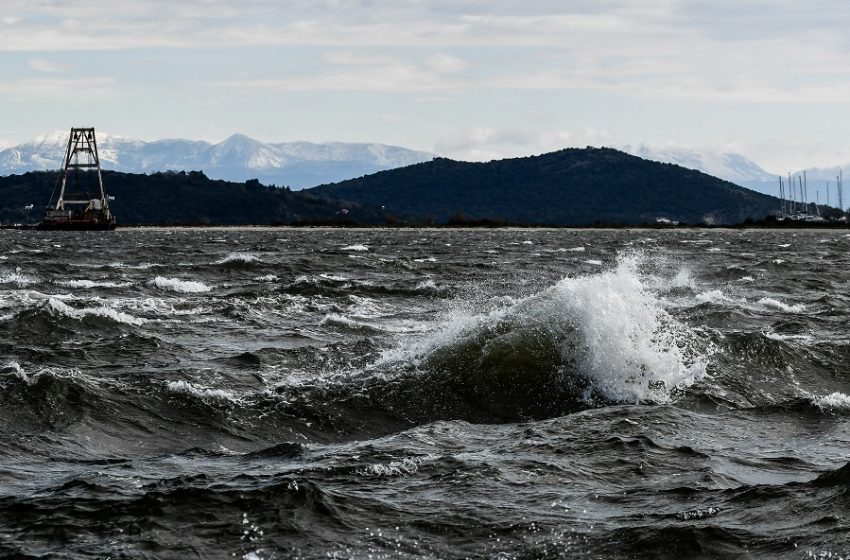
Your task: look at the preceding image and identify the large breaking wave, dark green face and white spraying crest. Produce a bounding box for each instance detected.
[394,255,707,402]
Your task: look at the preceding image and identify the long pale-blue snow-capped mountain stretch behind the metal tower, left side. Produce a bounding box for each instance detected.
[0,131,434,189]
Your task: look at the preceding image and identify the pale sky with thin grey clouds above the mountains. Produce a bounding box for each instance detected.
[0,0,850,173]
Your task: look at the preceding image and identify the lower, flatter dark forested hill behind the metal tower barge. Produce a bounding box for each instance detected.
[0,171,386,225]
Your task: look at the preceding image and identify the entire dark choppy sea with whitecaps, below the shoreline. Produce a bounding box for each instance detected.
[0,229,850,560]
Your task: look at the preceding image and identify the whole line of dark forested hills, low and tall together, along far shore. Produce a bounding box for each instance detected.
[0,148,779,225]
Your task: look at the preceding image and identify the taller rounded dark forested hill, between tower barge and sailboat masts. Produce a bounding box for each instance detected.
[306,148,779,225]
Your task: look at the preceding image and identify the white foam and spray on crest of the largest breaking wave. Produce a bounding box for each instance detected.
[400,255,706,402]
